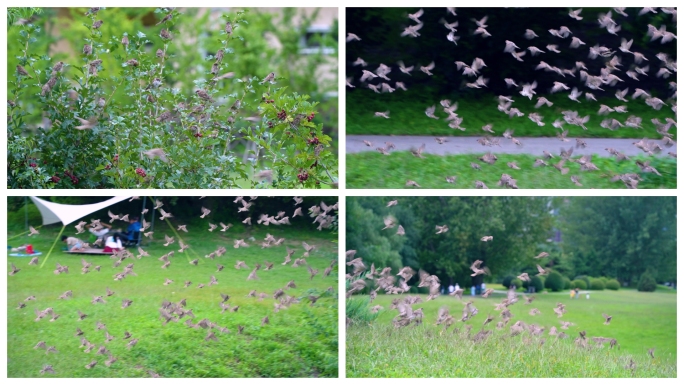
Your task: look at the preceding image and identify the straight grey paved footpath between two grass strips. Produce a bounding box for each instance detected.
[346,135,677,157]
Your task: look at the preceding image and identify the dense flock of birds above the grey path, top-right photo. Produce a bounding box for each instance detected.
[346,8,677,188]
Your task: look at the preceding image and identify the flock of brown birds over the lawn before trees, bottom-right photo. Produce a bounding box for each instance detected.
[346,200,655,369]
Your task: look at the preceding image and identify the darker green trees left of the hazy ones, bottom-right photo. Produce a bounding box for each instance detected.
[346,197,552,286]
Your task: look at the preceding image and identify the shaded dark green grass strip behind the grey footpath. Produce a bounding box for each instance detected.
[346,89,677,139]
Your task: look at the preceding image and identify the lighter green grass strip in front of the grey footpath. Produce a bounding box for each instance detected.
[347,151,677,189]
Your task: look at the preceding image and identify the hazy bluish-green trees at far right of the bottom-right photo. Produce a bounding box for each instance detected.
[559,197,677,283]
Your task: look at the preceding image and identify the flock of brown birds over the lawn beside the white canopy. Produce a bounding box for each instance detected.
[10,197,338,377]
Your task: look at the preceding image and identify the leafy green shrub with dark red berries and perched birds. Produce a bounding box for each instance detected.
[7,8,337,189]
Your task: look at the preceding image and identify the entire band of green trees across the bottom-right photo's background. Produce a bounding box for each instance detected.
[346,197,676,286]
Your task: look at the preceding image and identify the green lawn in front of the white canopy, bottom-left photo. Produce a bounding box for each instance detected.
[7,220,338,377]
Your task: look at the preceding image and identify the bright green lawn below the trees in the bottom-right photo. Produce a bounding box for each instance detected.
[347,290,677,378]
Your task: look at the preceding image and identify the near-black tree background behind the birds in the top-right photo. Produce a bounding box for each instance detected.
[346,7,677,100]
